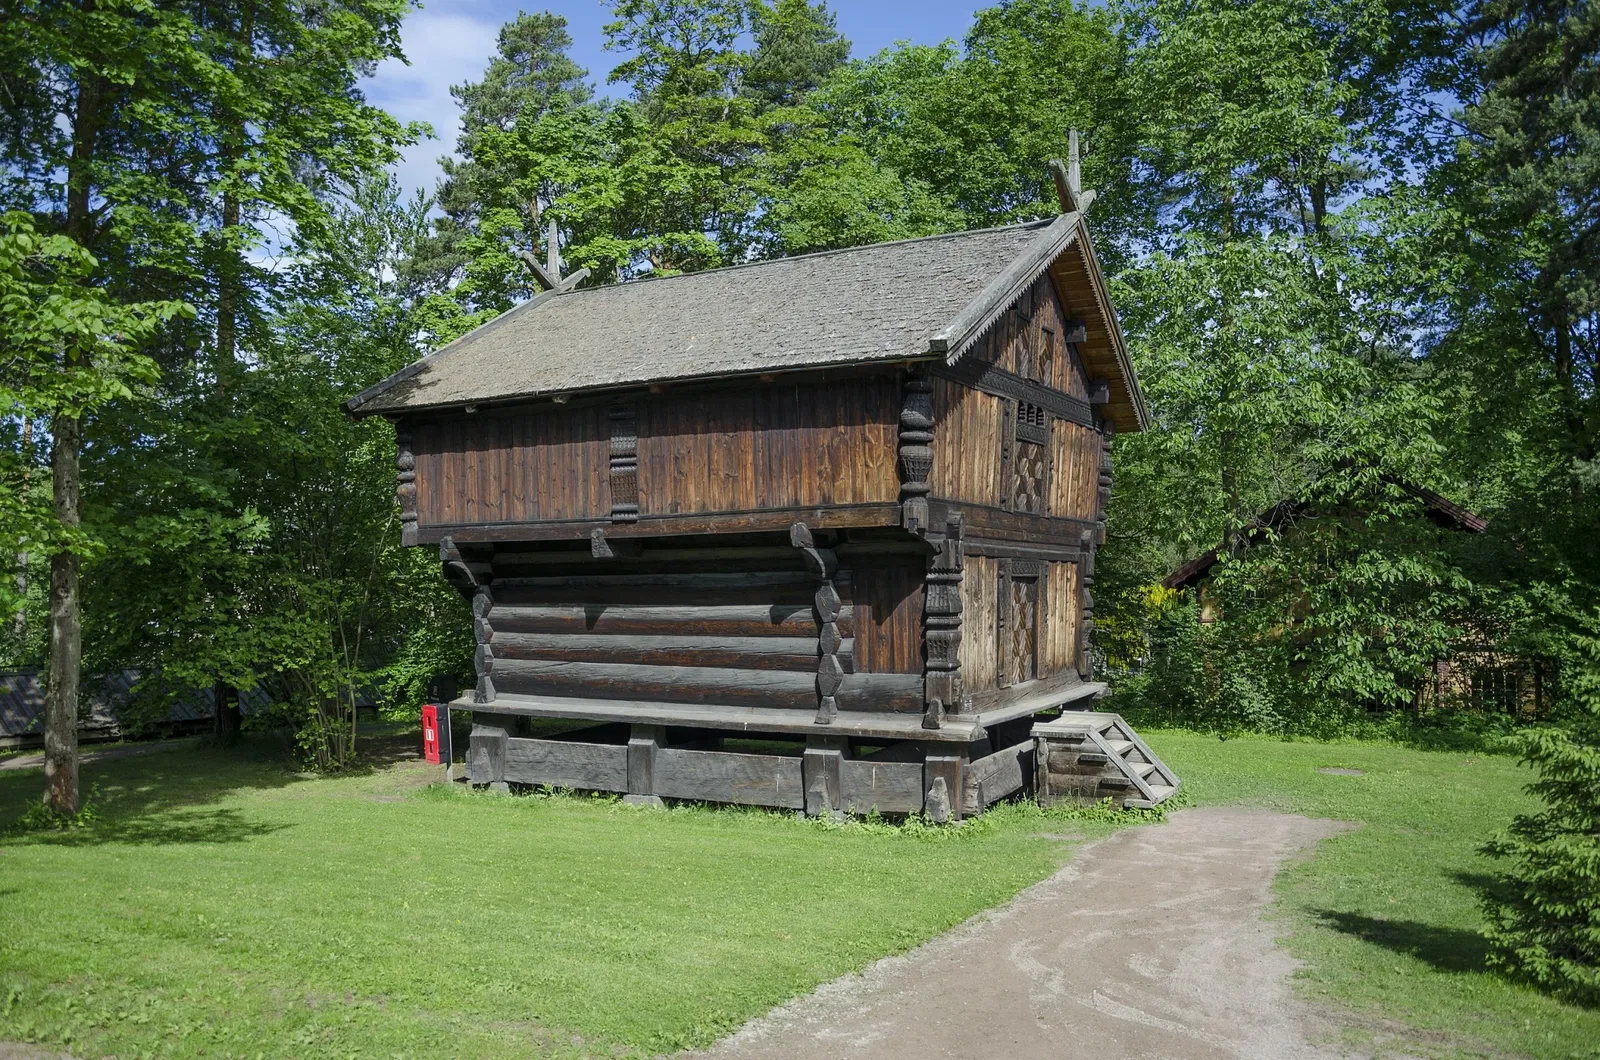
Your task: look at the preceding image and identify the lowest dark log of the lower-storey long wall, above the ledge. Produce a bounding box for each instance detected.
[494,660,922,714]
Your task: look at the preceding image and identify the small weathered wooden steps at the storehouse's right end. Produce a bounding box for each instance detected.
[1032,711,1178,810]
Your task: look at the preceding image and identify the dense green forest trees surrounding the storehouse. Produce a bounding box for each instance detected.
[0,0,1600,767]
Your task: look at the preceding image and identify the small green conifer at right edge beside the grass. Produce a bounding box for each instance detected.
[1483,620,1600,1006]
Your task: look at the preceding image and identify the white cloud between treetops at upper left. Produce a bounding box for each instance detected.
[365,11,501,202]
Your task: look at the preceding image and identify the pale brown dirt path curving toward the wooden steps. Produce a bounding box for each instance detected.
[694,809,1369,1060]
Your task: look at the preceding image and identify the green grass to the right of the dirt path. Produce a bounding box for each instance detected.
[1141,732,1600,1058]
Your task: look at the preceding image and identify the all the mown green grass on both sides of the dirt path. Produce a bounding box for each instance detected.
[0,733,1600,1057]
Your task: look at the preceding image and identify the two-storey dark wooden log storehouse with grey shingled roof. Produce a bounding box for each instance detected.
[349,163,1176,820]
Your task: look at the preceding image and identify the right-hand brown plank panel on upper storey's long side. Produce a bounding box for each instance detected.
[638,376,901,516]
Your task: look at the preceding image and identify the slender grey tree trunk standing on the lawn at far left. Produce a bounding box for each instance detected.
[45,415,83,815]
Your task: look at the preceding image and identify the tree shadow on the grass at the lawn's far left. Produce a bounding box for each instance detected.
[0,737,304,847]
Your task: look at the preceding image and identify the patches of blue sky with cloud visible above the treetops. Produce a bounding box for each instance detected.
[366,0,986,201]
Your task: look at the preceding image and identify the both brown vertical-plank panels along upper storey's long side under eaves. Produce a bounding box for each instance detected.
[413,375,901,527]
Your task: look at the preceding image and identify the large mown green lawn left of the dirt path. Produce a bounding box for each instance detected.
[0,739,1132,1057]
